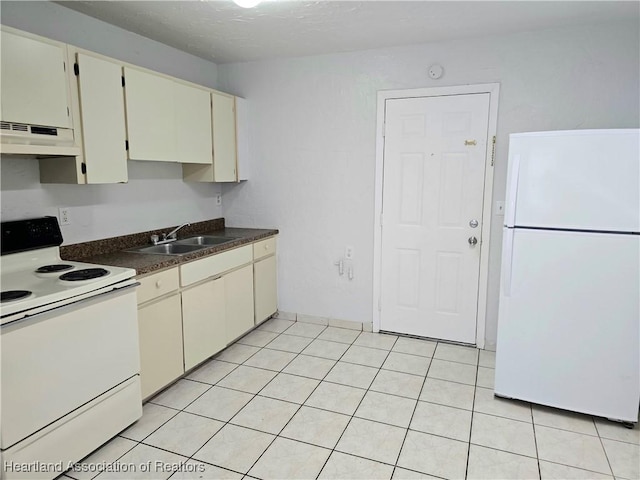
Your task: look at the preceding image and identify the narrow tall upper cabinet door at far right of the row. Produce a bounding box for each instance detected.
[211,92,237,182]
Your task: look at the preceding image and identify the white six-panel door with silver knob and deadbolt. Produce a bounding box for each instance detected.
[380,93,490,343]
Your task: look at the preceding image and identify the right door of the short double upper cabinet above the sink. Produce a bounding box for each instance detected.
[174,82,213,165]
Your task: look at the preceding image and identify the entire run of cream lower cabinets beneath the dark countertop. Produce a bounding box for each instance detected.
[138,237,277,399]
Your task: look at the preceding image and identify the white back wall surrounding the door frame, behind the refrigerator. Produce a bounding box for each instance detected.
[218,22,640,348]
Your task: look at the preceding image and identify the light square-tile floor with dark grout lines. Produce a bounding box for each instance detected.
[66,319,640,480]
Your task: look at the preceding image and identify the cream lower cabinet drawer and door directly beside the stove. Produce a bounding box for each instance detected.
[138,268,184,398]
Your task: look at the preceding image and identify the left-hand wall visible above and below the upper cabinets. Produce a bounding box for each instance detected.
[0,1,222,244]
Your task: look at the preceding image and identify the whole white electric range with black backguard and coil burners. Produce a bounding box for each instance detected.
[0,217,142,479]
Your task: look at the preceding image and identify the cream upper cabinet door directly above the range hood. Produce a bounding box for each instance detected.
[0,31,71,128]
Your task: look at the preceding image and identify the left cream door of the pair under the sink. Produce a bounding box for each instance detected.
[182,277,227,370]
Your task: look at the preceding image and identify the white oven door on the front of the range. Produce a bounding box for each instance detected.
[0,283,140,450]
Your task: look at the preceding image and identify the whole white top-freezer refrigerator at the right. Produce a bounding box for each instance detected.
[495,129,640,422]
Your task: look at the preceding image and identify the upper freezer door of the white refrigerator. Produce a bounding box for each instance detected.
[505,129,640,232]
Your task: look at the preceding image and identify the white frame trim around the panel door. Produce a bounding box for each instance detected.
[373,83,500,348]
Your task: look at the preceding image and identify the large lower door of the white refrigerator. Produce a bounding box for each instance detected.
[495,228,640,421]
